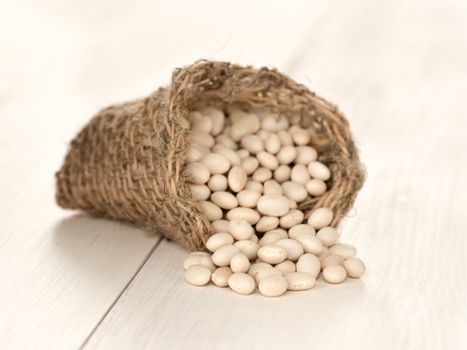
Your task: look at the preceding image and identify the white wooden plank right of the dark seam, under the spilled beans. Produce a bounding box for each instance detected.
[86,1,467,349]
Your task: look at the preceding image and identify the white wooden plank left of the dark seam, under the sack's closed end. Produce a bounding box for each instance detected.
[0,0,320,349]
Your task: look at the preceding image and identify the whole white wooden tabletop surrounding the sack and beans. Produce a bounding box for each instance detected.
[0,0,467,350]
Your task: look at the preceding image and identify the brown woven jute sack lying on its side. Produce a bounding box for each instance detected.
[56,61,364,250]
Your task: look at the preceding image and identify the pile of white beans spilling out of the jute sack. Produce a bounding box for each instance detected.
[183,107,365,297]
